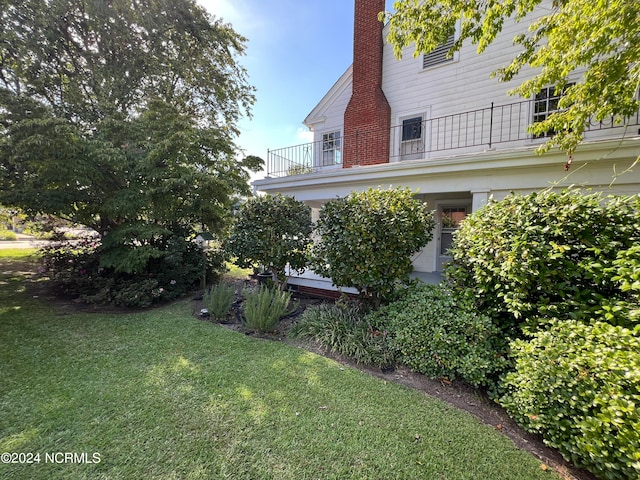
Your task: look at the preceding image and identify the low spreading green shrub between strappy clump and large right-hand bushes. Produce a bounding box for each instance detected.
[367,284,506,386]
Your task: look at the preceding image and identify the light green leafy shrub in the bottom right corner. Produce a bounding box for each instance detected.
[500,320,640,479]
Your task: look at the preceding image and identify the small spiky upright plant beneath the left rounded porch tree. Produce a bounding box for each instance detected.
[244,287,291,332]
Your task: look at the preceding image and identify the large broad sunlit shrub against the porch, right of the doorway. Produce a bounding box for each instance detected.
[447,190,640,328]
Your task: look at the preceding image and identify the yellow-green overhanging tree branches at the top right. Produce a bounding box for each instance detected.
[381,0,640,158]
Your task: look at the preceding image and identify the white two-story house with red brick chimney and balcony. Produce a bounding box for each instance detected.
[254,0,640,296]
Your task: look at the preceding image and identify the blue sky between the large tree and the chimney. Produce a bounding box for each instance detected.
[197,0,392,176]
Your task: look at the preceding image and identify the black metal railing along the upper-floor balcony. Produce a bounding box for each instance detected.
[267,101,640,177]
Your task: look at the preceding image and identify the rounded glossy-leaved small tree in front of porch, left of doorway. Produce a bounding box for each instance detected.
[313,188,435,306]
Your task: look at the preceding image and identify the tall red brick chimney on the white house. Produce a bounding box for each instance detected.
[343,0,391,168]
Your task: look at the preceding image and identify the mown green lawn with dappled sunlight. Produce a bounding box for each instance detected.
[0,253,558,480]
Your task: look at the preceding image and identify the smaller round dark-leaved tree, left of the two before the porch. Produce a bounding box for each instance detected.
[227,194,313,288]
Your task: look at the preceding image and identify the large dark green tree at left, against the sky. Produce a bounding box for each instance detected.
[0,0,261,274]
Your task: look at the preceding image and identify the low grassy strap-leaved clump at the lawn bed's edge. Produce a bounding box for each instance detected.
[289,303,395,368]
